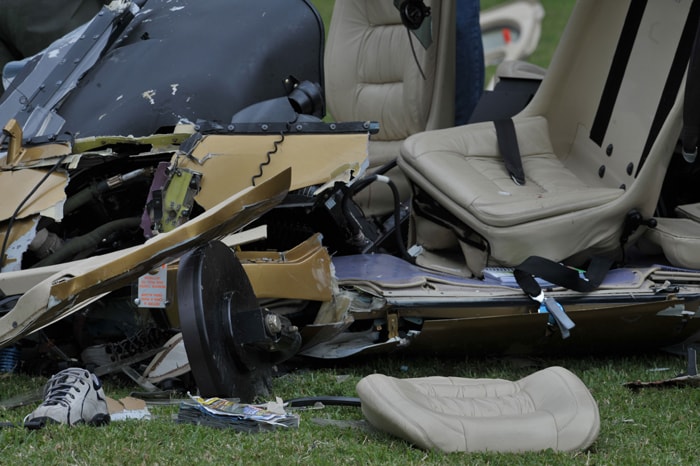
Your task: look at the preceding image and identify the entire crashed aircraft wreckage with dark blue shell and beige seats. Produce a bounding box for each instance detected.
[0,0,700,400]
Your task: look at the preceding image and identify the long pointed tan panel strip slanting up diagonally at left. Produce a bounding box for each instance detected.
[0,170,291,346]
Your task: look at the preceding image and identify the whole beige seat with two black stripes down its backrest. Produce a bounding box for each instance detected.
[399,0,692,275]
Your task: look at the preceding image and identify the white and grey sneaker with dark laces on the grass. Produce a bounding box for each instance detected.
[24,367,110,429]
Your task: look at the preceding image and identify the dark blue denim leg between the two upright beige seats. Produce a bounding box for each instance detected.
[455,0,484,125]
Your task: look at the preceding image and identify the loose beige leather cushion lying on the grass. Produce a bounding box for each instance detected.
[357,366,600,452]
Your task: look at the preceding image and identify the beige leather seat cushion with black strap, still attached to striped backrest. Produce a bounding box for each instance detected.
[399,116,625,266]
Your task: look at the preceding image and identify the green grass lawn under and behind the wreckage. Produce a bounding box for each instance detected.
[0,0,700,465]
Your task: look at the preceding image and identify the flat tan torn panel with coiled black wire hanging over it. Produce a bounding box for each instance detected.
[175,133,368,209]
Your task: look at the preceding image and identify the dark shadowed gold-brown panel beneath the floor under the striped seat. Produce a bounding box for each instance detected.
[410,300,700,354]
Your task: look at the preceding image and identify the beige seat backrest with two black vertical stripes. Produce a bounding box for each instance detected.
[521,0,700,215]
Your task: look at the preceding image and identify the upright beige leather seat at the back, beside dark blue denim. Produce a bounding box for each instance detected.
[324,0,455,214]
